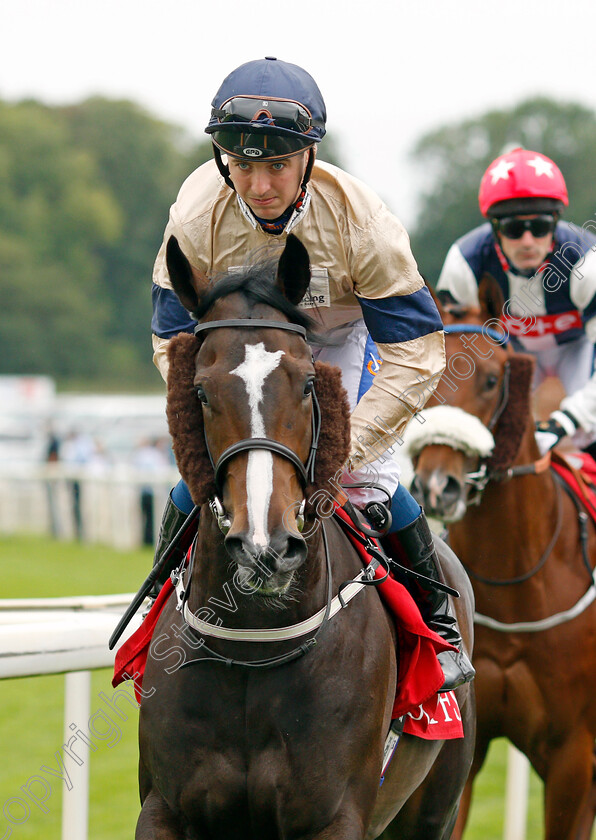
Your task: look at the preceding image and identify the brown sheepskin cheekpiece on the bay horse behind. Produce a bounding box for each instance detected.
[487,353,534,473]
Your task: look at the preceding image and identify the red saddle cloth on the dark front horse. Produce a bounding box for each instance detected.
[112,508,463,740]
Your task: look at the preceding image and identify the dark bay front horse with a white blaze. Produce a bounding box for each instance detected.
[135,236,475,840]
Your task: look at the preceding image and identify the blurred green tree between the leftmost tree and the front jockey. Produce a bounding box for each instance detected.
[62,97,211,381]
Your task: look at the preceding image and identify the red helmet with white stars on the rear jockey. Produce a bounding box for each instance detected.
[478,149,569,218]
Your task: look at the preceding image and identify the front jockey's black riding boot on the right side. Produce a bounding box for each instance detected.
[395,512,475,691]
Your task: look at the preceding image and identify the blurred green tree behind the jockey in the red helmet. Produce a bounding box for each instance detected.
[412,98,596,285]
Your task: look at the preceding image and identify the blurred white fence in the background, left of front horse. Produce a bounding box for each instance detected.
[0,462,179,549]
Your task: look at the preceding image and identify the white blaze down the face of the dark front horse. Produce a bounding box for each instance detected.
[230,341,284,548]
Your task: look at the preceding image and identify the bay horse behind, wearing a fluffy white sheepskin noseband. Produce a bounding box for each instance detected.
[406,276,596,840]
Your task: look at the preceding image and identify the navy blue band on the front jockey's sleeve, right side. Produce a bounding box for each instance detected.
[358,286,443,344]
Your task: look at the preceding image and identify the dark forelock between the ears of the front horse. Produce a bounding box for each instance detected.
[193,259,318,338]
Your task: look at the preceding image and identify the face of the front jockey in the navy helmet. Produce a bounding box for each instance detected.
[228,152,308,219]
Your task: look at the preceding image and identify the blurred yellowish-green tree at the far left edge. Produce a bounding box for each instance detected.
[0,102,122,377]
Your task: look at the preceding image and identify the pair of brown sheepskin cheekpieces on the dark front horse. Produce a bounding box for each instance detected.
[167,333,350,505]
